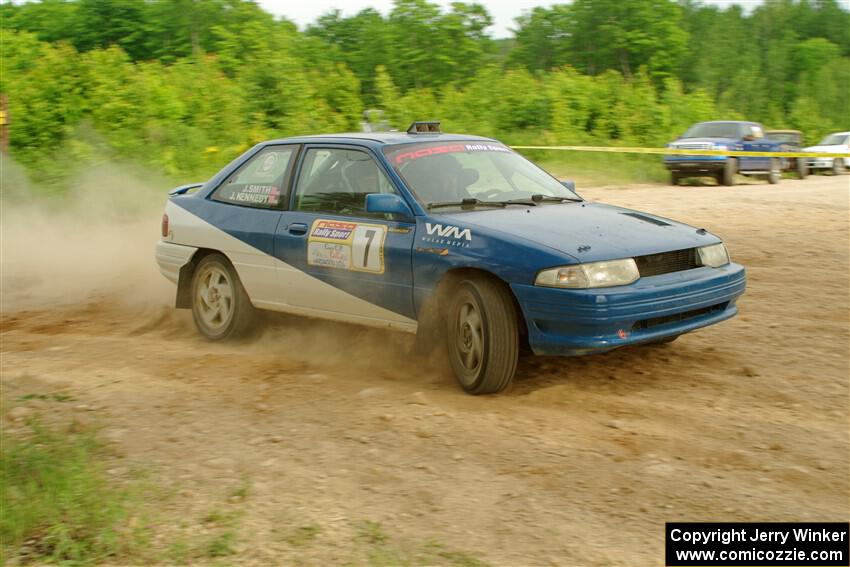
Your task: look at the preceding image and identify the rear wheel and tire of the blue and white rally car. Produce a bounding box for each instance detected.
[192,254,257,341]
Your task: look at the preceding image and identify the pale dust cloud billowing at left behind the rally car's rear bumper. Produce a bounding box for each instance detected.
[0,156,173,312]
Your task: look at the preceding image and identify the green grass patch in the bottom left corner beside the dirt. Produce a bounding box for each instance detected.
[0,421,146,564]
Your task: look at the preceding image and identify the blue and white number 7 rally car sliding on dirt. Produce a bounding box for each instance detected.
[156,122,745,394]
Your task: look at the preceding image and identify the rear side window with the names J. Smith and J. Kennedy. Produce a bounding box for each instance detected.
[213,146,296,209]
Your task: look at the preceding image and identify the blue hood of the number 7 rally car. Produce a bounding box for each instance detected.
[441,201,720,262]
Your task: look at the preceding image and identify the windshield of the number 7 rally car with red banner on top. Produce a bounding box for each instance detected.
[384,142,580,207]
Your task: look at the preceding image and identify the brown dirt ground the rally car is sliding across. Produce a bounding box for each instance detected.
[0,176,850,565]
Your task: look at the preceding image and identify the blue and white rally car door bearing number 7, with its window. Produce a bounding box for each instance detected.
[275,145,415,329]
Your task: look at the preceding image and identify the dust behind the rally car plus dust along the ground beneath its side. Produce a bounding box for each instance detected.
[0,157,420,380]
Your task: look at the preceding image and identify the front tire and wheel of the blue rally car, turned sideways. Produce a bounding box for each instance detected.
[446,277,519,395]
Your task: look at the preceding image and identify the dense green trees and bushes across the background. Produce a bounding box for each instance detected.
[0,0,850,183]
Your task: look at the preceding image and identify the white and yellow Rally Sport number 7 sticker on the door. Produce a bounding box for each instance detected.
[307,219,387,274]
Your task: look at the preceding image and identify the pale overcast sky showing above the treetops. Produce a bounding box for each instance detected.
[258,0,763,38]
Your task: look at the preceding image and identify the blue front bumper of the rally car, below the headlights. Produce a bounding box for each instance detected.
[511,264,746,356]
